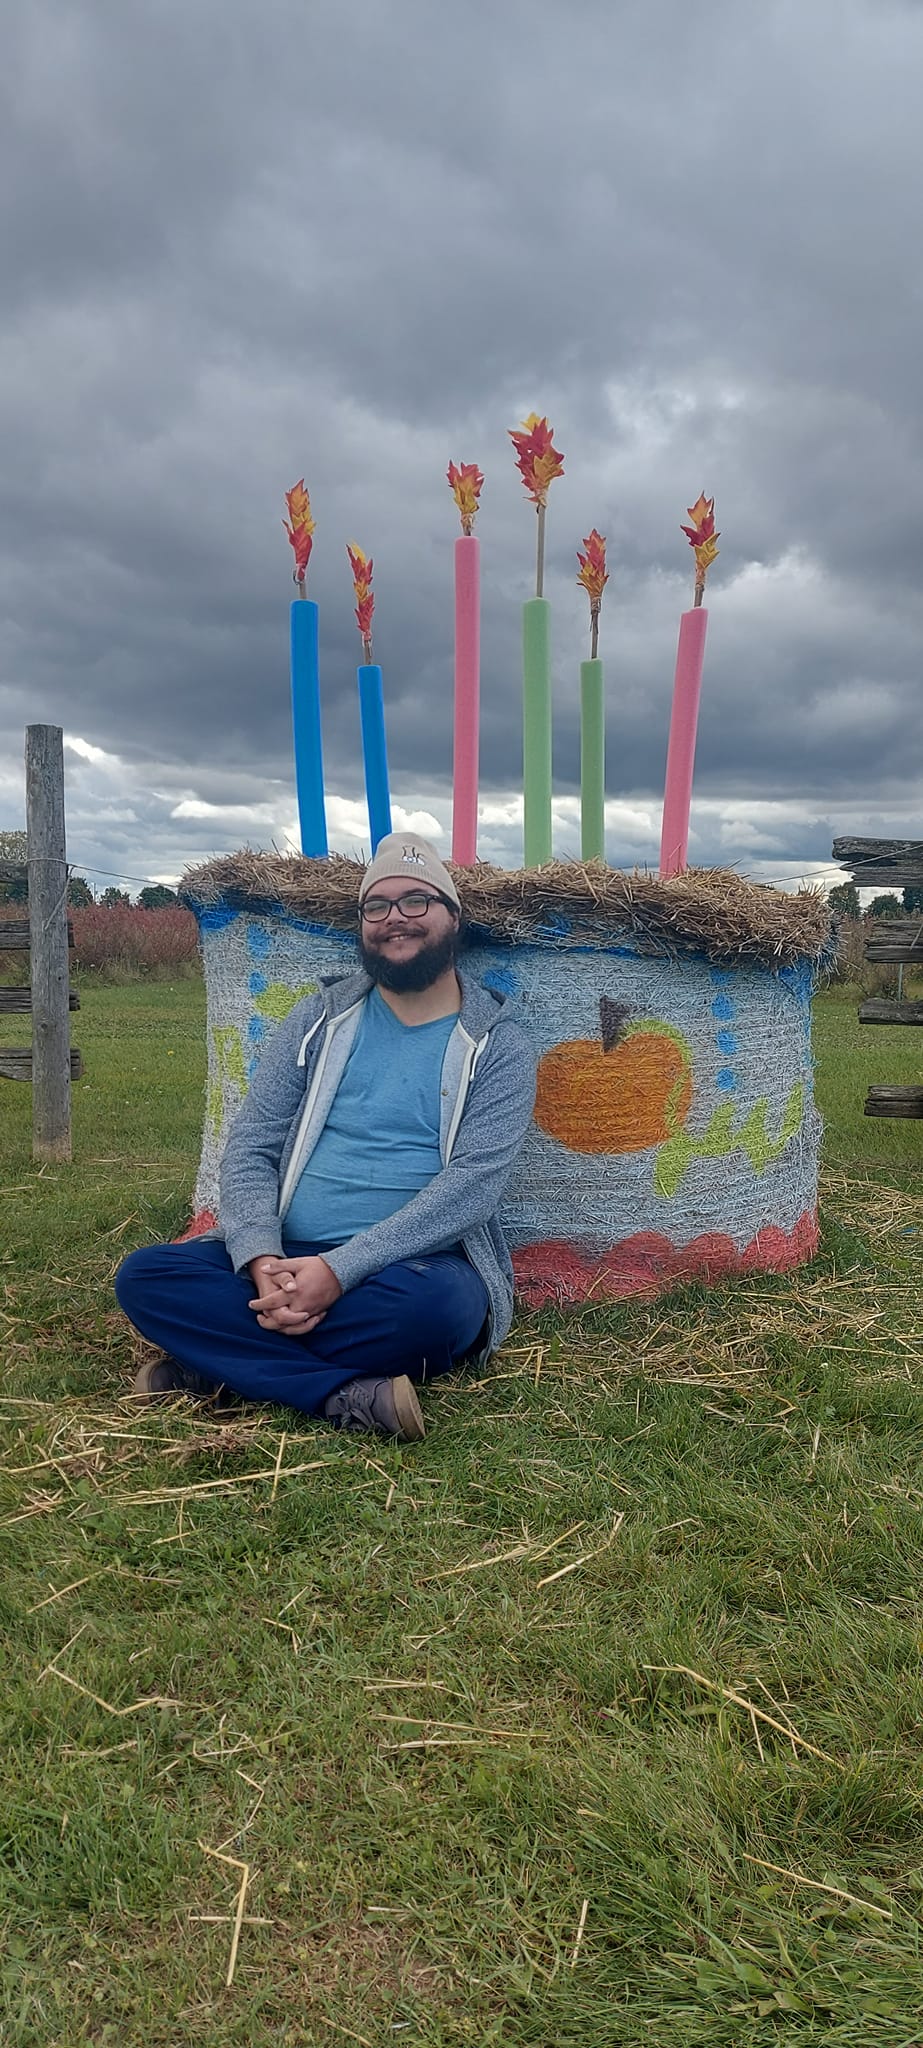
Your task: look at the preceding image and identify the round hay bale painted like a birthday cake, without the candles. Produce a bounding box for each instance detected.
[184,854,831,1305]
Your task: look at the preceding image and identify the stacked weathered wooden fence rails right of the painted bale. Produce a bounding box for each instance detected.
[833,838,923,1118]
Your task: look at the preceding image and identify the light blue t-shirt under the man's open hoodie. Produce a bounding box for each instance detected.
[284,989,456,1245]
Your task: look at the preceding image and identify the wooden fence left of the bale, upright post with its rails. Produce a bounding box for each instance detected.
[0,725,82,1159]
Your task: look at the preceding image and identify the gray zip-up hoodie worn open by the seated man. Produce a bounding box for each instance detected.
[219,973,536,1356]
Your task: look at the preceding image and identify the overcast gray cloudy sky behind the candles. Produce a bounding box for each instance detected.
[0,0,923,885]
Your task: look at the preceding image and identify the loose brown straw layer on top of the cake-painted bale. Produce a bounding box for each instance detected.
[180,848,833,967]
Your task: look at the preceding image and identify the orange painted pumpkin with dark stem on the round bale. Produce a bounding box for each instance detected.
[534,995,692,1153]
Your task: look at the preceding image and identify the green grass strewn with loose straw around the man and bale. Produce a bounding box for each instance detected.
[0,981,923,2048]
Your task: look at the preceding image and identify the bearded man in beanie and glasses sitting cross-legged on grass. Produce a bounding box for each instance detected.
[115,834,534,1438]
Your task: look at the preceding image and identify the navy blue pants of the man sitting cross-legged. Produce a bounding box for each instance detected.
[115,1237,487,1415]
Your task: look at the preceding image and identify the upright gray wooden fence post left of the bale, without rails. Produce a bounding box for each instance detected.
[27,725,72,1159]
